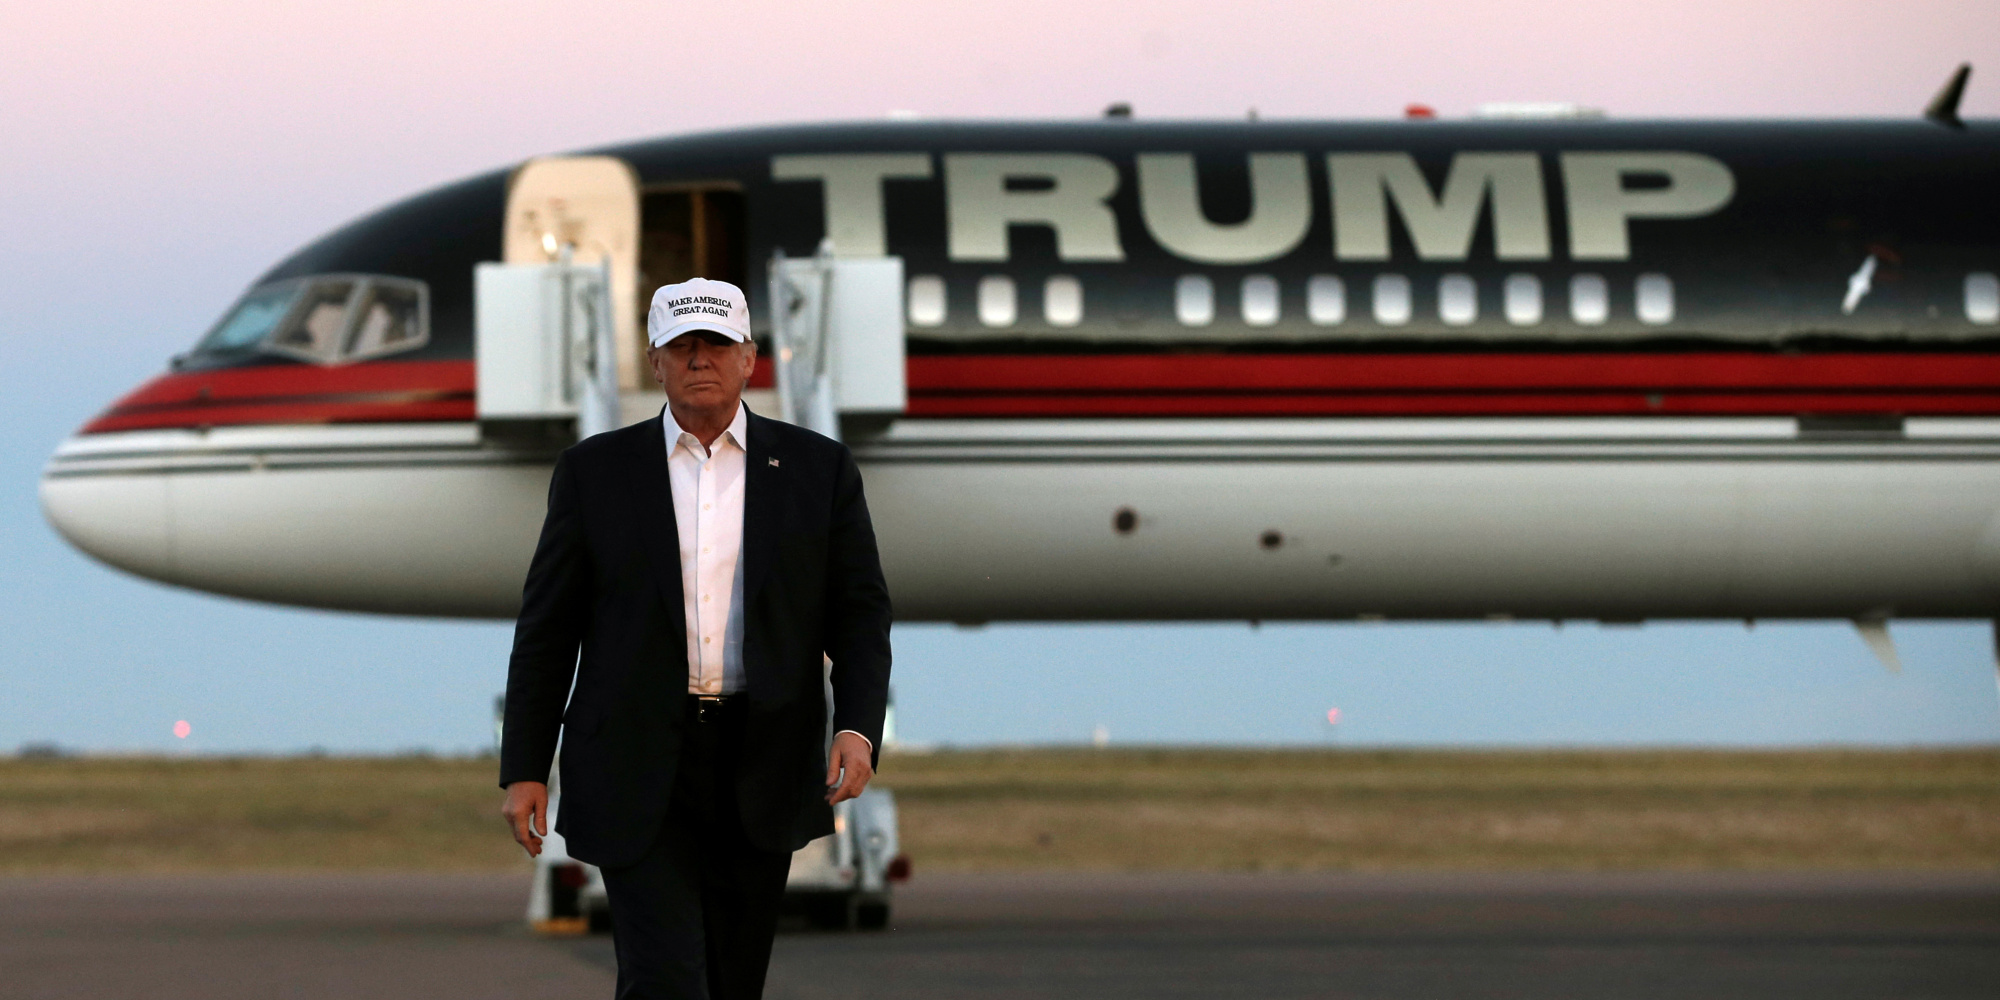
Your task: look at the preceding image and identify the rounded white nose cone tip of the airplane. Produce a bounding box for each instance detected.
[40,434,174,582]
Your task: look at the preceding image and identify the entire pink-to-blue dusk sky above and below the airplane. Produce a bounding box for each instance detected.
[0,0,2000,754]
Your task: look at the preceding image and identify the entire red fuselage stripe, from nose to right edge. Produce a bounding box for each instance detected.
[84,352,2000,434]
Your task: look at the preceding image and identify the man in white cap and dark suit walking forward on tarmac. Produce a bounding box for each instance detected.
[500,278,890,1000]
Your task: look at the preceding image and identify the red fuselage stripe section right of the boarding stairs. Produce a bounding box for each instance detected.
[908,352,2000,416]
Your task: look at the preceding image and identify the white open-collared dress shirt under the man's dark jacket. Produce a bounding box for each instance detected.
[660,404,874,748]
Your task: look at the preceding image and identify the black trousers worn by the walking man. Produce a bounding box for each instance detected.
[604,698,792,1000]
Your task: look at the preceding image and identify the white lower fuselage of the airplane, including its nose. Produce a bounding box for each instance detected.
[42,418,2000,622]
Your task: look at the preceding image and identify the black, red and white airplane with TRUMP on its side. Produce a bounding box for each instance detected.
[27,68,2000,656]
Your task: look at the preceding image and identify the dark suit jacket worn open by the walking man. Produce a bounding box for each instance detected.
[500,414,890,866]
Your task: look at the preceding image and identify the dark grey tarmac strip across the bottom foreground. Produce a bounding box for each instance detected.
[0,872,2000,1000]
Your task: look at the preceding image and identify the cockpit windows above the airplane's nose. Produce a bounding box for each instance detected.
[194,274,430,364]
